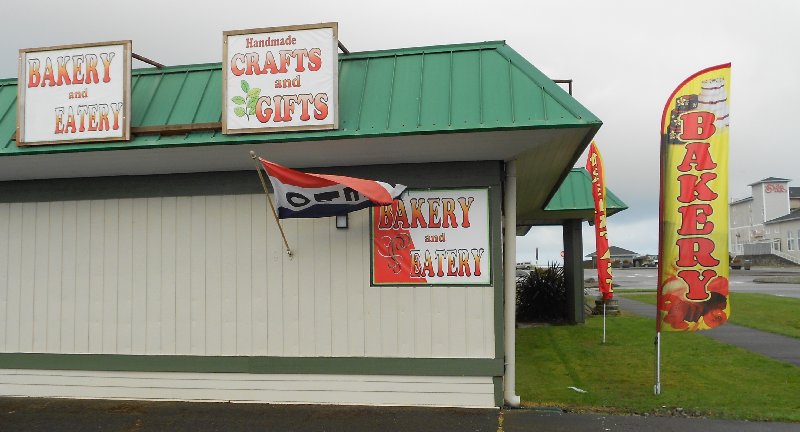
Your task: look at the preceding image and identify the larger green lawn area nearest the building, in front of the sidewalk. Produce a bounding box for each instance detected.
[517,315,800,422]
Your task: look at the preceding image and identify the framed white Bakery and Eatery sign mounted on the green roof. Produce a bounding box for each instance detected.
[17,41,131,145]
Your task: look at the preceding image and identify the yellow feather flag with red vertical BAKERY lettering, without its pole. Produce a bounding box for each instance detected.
[656,64,730,331]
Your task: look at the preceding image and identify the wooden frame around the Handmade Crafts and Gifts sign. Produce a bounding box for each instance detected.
[221,21,339,135]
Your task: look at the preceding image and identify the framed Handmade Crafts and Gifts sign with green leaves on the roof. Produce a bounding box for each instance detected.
[222,23,339,134]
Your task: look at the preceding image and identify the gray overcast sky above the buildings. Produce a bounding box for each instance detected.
[0,0,800,263]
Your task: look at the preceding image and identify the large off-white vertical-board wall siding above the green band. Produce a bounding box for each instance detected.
[0,195,494,358]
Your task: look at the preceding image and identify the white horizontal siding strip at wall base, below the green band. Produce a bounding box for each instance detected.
[0,369,495,407]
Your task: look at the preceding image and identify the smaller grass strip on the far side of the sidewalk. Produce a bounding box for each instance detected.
[622,292,800,340]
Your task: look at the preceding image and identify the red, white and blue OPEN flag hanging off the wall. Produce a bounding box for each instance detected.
[258,158,406,219]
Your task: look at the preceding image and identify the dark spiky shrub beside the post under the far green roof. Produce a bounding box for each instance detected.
[517,263,567,322]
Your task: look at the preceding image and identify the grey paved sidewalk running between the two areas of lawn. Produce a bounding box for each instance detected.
[615,296,800,367]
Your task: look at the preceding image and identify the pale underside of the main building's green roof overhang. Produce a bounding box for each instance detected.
[0,125,597,225]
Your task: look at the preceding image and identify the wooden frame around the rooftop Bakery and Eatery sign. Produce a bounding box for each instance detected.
[16,40,133,147]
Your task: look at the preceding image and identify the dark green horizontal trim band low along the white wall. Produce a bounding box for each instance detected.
[0,353,503,377]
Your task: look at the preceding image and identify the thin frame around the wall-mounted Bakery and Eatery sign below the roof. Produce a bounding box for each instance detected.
[369,186,495,288]
